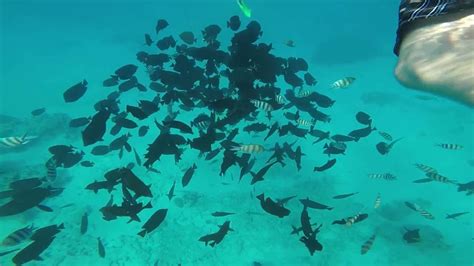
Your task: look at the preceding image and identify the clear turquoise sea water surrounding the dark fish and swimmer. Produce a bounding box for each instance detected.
[0,0,474,265]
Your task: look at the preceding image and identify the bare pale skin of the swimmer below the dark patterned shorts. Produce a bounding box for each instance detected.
[395,9,474,107]
